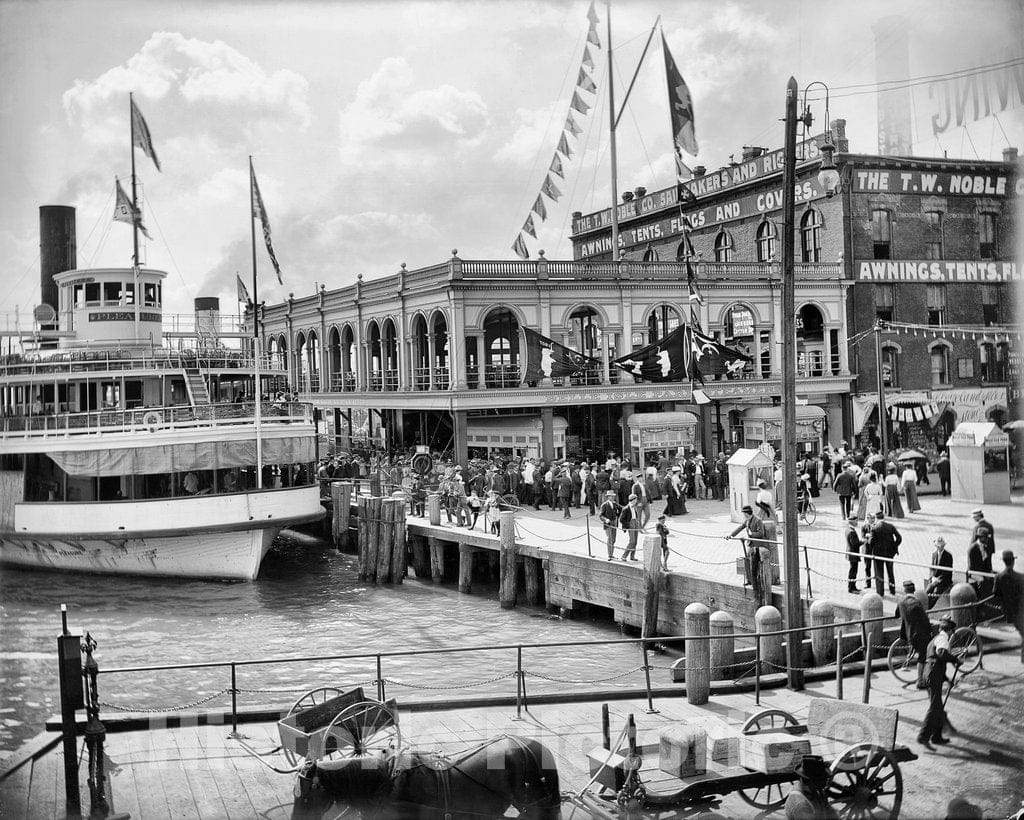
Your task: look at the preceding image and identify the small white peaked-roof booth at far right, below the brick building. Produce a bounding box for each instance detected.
[946,422,1010,504]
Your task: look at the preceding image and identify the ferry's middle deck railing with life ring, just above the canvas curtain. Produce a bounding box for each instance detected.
[0,400,312,439]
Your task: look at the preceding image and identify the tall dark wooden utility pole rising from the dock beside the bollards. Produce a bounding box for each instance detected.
[781,77,804,690]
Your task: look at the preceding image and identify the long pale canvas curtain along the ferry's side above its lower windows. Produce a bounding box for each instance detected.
[47,436,314,476]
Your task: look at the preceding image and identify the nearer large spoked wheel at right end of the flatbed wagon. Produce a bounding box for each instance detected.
[826,743,903,820]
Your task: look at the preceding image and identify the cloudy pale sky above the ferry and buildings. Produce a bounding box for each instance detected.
[0,0,1024,327]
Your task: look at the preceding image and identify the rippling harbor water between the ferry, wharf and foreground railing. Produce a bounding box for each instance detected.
[0,537,651,754]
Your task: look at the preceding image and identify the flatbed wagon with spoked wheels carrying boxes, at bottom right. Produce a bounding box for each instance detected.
[567,698,918,820]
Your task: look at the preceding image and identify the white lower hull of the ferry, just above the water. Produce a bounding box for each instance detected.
[0,487,324,580]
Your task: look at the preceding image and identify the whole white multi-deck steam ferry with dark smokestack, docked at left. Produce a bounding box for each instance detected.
[0,131,324,579]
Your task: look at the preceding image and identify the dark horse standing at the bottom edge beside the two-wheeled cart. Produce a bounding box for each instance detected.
[292,735,561,820]
